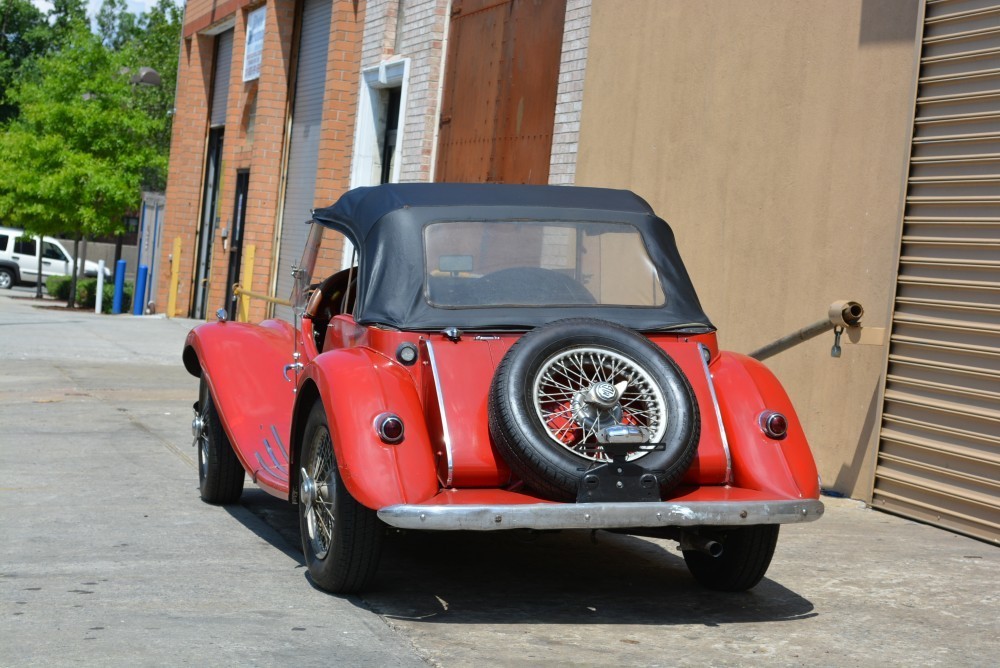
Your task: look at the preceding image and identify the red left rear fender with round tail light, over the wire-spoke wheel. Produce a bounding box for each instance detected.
[293,348,438,509]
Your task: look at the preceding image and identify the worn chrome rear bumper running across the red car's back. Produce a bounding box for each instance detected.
[378,499,823,531]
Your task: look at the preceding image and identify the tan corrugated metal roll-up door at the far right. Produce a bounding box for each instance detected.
[872,0,1000,543]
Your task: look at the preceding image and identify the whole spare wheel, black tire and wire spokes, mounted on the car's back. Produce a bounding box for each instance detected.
[488,318,701,501]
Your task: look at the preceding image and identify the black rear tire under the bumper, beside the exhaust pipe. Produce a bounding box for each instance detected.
[684,524,780,591]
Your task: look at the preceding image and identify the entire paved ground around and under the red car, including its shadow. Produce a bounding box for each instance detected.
[0,291,1000,667]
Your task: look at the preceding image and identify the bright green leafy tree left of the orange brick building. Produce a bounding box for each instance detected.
[0,0,181,305]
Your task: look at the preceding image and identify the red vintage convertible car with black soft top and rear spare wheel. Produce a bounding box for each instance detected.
[184,184,823,593]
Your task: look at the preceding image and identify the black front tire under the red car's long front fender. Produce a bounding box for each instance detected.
[196,378,246,505]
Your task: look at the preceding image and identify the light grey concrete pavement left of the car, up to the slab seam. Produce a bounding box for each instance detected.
[0,295,426,666]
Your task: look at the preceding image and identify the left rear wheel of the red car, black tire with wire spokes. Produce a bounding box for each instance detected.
[299,401,385,594]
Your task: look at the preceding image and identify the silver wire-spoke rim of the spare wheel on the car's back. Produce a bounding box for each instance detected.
[532,346,669,462]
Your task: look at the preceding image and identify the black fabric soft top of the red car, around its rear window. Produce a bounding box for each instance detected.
[313,183,714,332]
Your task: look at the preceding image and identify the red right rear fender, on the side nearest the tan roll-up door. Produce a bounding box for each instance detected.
[711,352,820,499]
